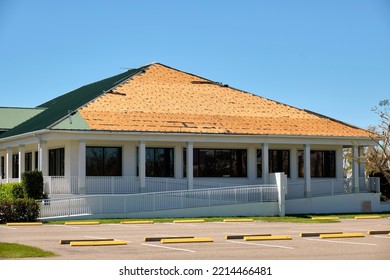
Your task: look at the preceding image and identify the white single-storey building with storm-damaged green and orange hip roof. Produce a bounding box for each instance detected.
[0,63,386,218]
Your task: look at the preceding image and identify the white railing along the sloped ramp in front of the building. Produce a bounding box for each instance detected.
[40,185,278,219]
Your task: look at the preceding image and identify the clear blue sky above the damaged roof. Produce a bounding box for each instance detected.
[0,0,390,127]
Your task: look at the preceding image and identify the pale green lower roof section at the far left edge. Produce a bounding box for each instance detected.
[0,107,45,130]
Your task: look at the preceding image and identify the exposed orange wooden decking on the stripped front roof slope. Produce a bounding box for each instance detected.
[80,63,369,137]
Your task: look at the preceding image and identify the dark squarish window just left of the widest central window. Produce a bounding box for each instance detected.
[145,148,174,177]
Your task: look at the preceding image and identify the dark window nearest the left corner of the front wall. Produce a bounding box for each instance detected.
[86,147,122,176]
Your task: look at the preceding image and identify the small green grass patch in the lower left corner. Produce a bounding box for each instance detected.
[0,242,56,259]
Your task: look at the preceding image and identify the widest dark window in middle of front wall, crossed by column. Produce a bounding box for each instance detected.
[184,149,247,177]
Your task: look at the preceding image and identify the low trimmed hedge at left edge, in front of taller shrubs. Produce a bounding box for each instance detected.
[0,199,39,224]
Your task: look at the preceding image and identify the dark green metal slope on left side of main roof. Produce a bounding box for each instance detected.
[0,66,147,138]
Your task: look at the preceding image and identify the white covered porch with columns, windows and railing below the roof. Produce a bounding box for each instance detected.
[0,131,379,199]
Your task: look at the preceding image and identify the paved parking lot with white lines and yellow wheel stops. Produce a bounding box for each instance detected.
[0,218,390,260]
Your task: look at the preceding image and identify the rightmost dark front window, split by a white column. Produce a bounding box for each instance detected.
[298,150,336,178]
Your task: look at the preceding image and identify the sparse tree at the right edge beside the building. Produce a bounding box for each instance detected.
[365,99,390,199]
